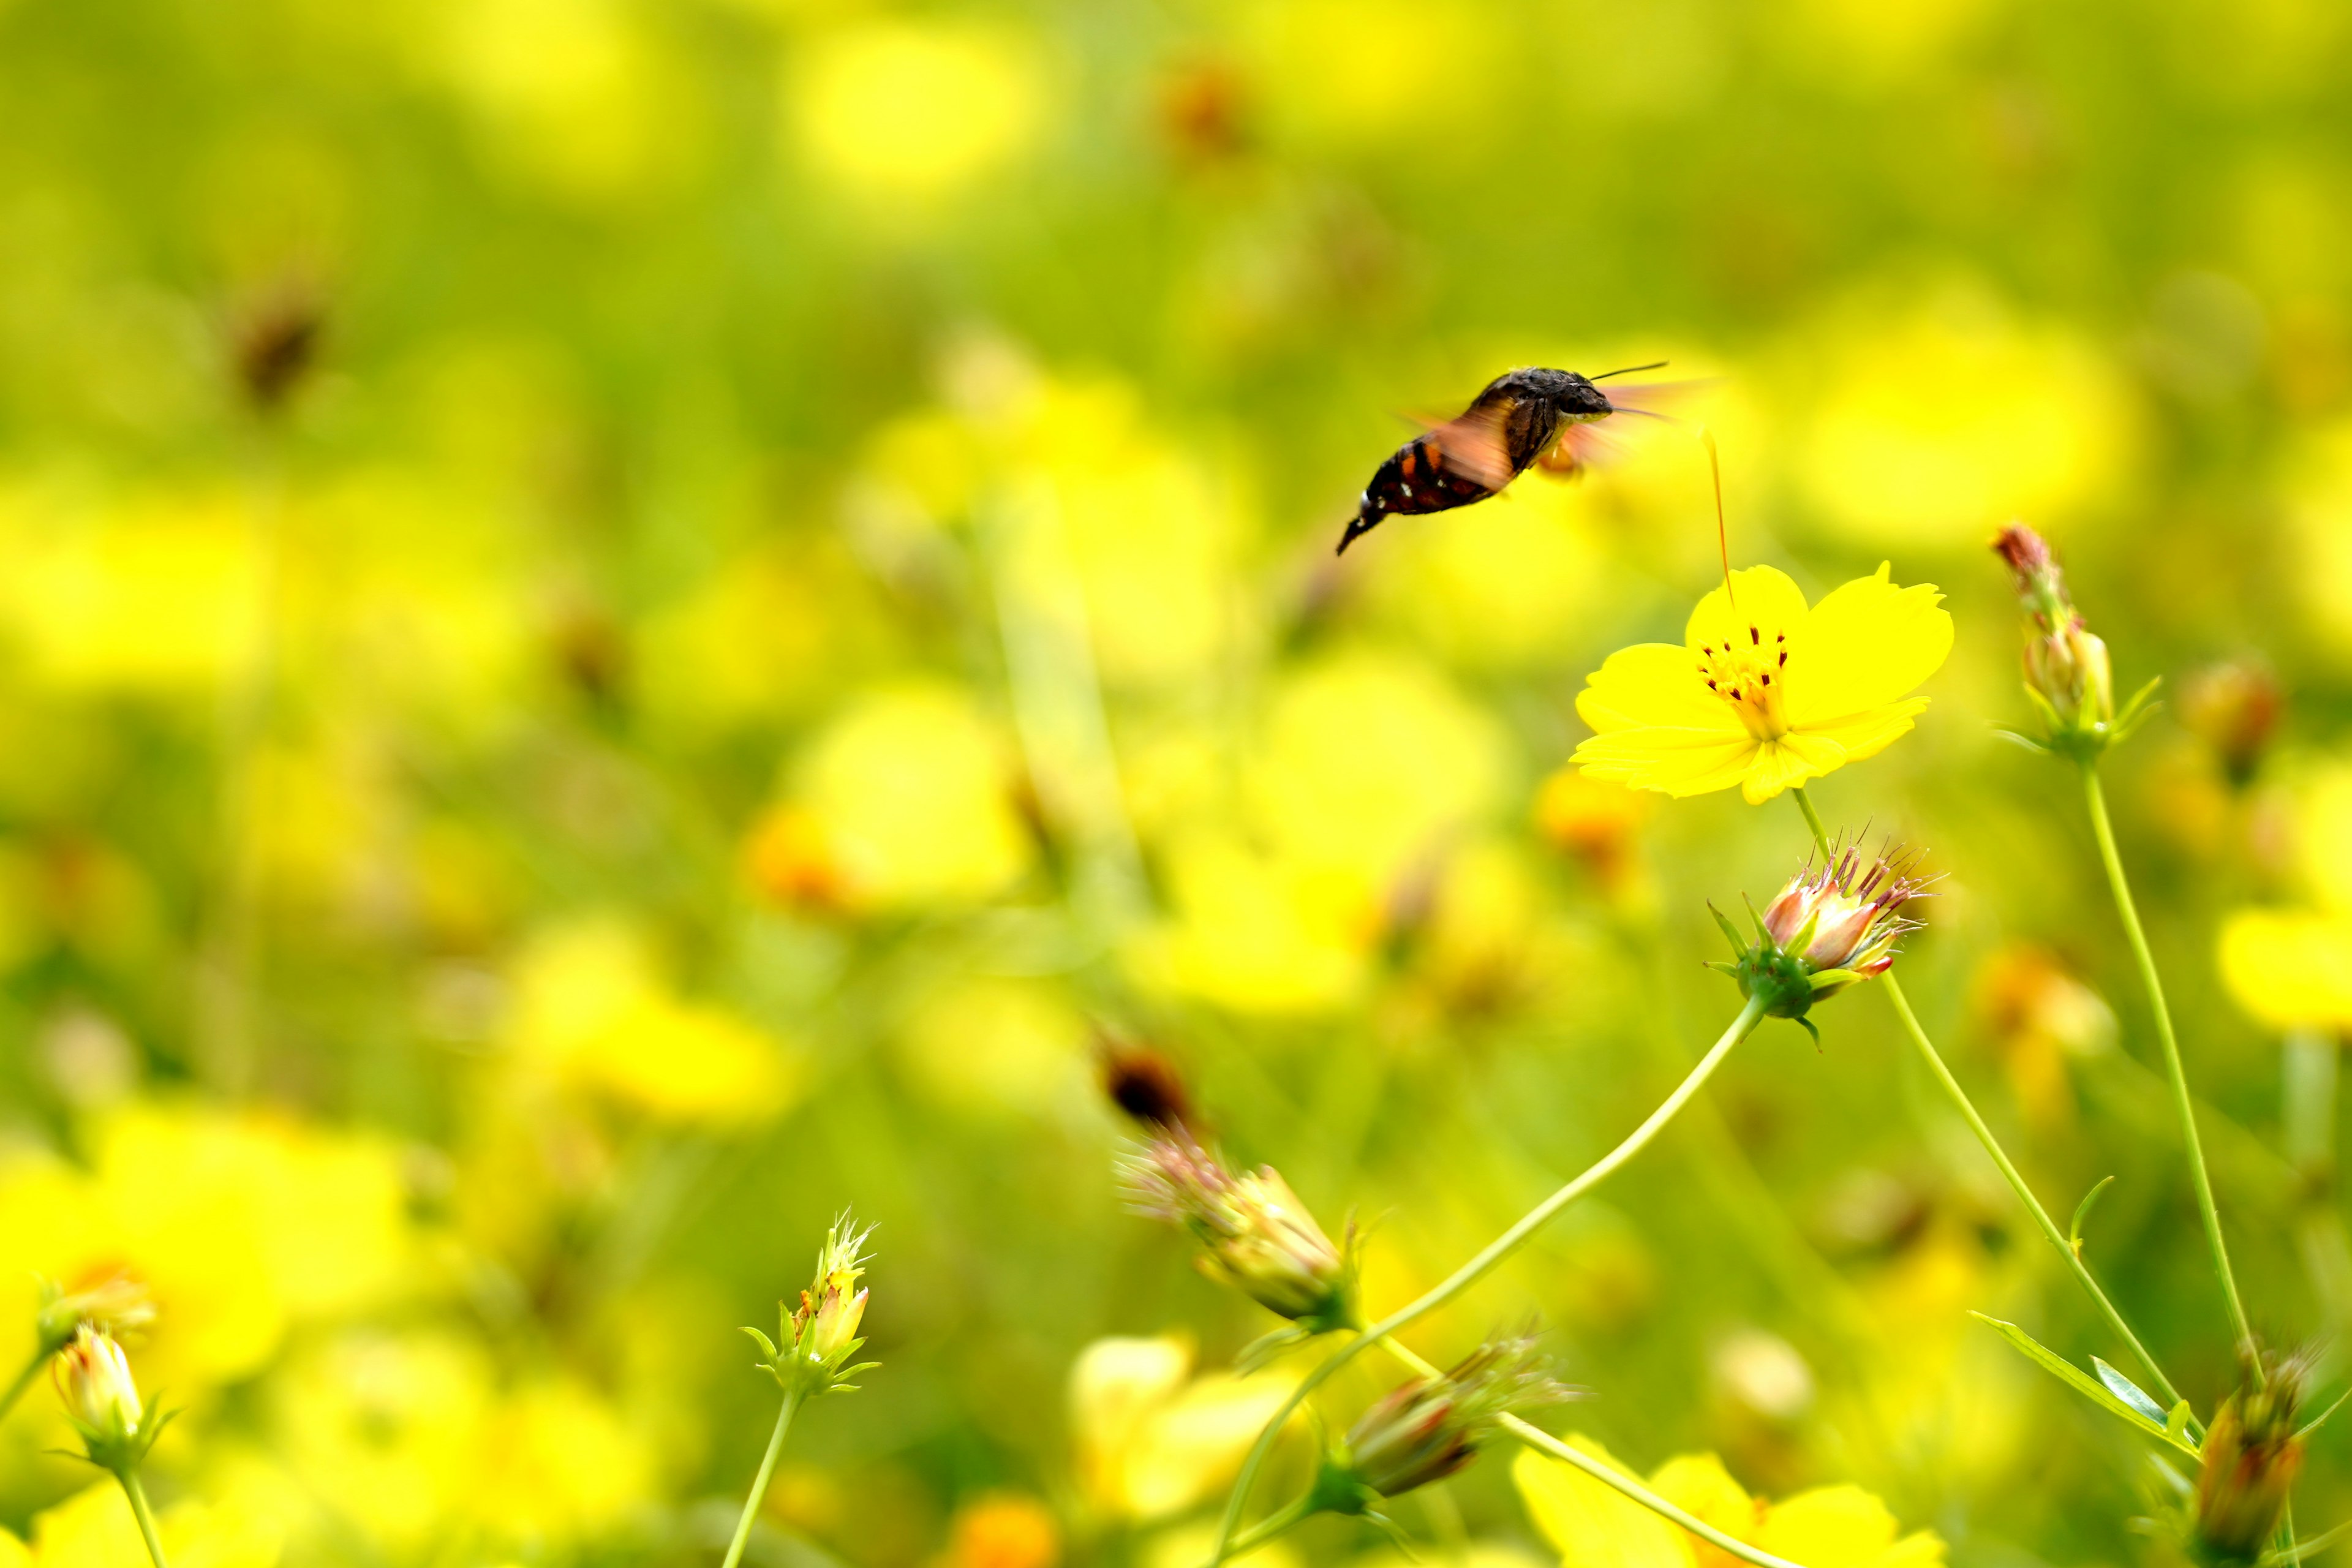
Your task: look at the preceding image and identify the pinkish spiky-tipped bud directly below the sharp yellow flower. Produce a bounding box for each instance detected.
[1714,846,1924,1027]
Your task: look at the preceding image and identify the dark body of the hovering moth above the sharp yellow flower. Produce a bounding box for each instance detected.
[1338,364,1658,555]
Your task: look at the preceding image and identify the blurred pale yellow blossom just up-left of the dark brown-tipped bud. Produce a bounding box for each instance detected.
[899,978,1089,1117]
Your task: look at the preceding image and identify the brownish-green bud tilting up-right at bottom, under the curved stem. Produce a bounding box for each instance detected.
[1327,1335,1574,1498]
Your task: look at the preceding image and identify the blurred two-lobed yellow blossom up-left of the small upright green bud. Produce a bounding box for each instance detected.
[508,917,800,1126]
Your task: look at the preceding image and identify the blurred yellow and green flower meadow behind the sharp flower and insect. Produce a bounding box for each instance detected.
[0,0,2352,1568]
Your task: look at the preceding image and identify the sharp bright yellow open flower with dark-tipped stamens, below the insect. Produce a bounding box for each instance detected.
[1576,564,1952,804]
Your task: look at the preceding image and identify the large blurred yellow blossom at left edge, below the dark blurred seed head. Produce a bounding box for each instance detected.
[0,486,261,696]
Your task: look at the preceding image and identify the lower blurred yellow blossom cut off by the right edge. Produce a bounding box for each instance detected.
[2220,762,2352,1030]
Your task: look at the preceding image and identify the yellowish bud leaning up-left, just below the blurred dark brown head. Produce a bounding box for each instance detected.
[1126,1128,1355,1333]
